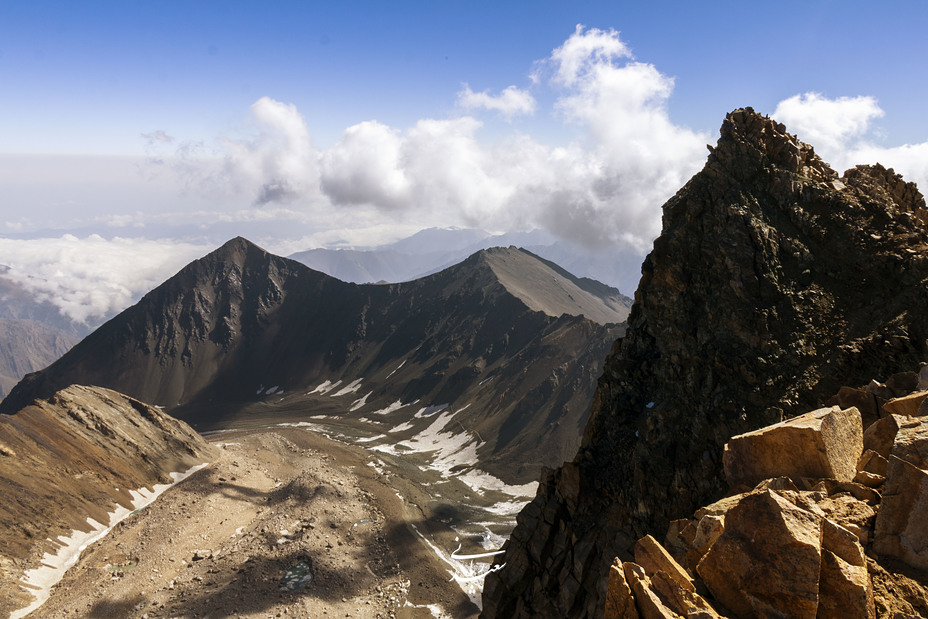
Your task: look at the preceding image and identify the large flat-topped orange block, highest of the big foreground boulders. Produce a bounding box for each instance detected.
[723,407,863,488]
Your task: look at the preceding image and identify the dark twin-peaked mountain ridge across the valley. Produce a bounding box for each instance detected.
[0,239,627,483]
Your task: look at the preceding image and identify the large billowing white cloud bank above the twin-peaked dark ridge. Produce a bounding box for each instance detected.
[154,26,709,252]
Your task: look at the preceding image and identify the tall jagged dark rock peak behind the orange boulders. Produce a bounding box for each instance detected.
[483,109,928,618]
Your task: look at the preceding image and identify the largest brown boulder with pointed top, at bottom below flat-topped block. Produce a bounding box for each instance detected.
[696,490,822,618]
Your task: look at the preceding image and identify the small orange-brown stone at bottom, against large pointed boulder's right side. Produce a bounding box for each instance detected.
[817,549,876,619]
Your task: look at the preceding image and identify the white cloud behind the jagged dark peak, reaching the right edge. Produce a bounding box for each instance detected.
[773,93,928,190]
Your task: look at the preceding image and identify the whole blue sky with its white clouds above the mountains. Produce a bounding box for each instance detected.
[0,0,928,320]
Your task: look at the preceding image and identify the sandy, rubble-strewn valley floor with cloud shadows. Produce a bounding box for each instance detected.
[23,428,478,619]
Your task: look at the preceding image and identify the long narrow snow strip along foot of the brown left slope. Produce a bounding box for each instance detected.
[10,462,209,619]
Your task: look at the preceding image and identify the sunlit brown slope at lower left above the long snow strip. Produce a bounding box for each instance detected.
[0,386,214,612]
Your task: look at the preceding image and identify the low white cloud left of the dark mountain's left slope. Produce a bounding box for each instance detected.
[0,234,213,324]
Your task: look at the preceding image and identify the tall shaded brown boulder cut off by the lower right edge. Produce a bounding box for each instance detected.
[873,456,928,570]
